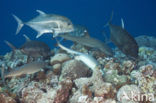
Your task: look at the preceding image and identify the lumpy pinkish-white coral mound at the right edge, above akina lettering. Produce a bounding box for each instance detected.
[131,65,156,102]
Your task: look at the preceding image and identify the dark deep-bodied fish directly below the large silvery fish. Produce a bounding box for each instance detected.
[5,34,52,58]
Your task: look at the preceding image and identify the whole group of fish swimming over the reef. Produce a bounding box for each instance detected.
[0,10,138,78]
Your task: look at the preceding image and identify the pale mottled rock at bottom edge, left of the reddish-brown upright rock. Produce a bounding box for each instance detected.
[22,81,57,103]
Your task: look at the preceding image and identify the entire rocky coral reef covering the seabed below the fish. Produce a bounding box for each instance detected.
[0,36,156,103]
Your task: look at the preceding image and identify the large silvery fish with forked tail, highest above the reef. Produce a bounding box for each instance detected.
[13,10,74,38]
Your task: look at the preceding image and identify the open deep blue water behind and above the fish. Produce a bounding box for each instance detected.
[0,0,156,54]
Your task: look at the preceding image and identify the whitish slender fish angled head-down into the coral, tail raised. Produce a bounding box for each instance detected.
[57,41,98,71]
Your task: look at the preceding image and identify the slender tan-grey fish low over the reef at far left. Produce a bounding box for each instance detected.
[4,61,46,78]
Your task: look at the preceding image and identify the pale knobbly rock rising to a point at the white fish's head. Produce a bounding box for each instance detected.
[74,67,116,99]
